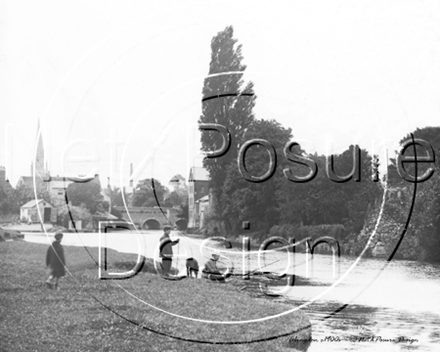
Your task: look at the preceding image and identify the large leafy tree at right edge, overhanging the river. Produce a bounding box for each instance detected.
[358,127,440,261]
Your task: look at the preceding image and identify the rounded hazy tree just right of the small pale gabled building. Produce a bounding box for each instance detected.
[67,182,104,214]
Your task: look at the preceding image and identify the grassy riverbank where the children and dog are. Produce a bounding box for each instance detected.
[0,241,310,351]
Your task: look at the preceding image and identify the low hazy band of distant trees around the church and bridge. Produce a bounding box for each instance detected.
[0,175,188,226]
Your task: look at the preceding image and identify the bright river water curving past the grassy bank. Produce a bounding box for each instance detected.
[25,231,440,352]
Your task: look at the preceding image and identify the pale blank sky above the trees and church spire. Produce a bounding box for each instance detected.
[0,0,440,190]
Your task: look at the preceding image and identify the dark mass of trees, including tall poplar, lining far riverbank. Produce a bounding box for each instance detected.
[198,27,440,260]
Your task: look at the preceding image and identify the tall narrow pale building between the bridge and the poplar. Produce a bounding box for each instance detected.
[188,166,209,227]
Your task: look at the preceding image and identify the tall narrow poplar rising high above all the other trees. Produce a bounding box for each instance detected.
[199,26,256,231]
